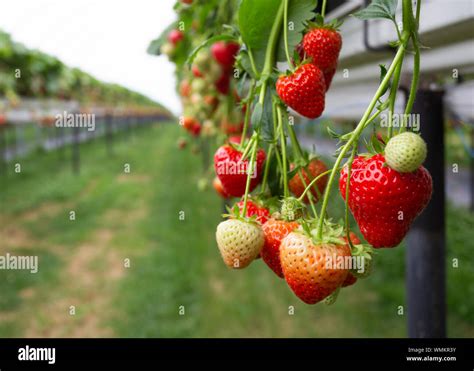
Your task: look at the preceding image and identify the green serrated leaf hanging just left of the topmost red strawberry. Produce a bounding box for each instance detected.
[277,0,318,62]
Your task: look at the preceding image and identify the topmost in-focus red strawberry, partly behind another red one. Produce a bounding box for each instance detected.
[303,26,342,71]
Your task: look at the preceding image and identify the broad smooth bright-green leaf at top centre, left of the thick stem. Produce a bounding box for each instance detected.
[238,0,281,71]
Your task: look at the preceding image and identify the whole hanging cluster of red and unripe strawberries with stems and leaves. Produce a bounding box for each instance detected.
[152,0,432,304]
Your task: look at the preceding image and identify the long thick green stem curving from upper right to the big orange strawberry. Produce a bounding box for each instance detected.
[317,43,406,239]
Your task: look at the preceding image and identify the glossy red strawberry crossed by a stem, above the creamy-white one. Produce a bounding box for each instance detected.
[214,144,265,197]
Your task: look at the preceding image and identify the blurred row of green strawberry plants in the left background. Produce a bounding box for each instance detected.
[0,31,162,107]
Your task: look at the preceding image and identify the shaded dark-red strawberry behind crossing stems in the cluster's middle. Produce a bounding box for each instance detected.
[288,158,328,203]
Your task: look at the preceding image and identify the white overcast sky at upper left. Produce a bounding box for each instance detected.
[0,0,180,113]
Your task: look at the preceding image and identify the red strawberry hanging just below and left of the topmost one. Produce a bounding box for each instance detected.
[276,63,326,119]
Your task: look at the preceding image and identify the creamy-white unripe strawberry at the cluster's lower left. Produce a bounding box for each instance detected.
[216,219,264,269]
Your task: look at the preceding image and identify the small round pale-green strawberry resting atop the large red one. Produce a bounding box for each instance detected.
[385,132,427,173]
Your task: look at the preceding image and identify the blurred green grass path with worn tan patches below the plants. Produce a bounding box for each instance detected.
[0,125,474,337]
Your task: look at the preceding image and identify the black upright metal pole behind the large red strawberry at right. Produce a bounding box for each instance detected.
[406,89,446,338]
